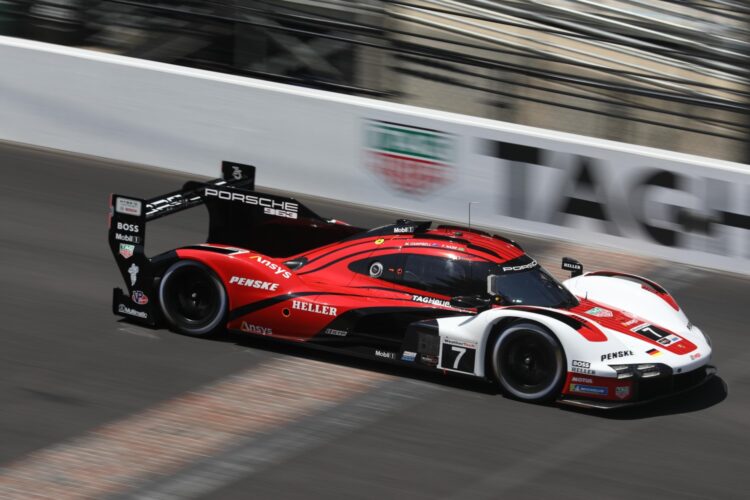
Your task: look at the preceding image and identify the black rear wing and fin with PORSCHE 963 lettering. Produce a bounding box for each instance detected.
[109,161,362,325]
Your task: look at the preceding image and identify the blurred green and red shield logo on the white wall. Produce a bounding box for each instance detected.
[365,120,456,195]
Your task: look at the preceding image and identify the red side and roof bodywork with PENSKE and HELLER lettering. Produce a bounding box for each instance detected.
[177,229,524,341]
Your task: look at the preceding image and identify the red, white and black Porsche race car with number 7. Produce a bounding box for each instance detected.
[109,162,716,408]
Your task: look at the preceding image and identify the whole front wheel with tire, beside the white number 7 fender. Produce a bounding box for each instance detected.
[492,323,566,403]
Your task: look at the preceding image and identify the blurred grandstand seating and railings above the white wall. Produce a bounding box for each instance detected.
[0,0,750,163]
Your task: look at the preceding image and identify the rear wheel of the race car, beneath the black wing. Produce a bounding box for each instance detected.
[159,260,228,337]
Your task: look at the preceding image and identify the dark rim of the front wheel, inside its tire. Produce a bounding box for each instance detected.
[500,330,558,395]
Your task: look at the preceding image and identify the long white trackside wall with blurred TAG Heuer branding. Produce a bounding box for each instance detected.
[0,37,750,274]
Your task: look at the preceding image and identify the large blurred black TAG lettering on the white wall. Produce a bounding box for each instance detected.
[482,140,750,262]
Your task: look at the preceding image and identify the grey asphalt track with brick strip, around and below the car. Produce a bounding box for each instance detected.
[0,144,750,499]
